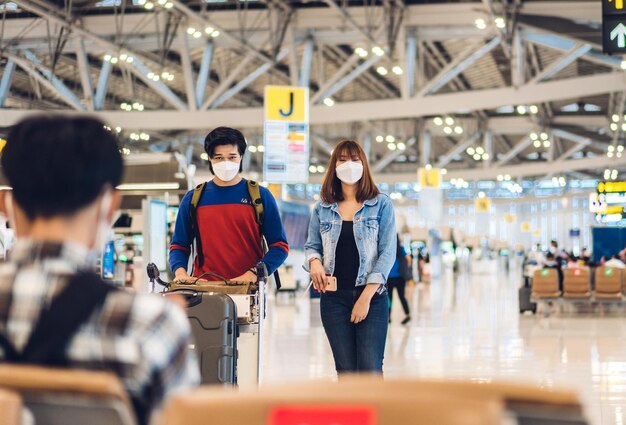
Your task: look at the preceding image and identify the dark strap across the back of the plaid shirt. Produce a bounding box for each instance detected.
[0,272,116,366]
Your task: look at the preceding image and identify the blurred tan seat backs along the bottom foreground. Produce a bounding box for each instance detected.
[0,365,588,425]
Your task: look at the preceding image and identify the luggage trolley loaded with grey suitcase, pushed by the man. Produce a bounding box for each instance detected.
[148,263,267,388]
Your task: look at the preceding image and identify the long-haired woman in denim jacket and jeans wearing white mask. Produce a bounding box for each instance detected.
[305,140,396,374]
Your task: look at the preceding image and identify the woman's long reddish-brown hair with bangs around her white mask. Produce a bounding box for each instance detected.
[320,140,380,204]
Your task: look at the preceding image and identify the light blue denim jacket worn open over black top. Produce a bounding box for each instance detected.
[304,194,397,293]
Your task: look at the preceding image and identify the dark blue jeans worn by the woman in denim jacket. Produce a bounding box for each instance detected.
[320,287,389,374]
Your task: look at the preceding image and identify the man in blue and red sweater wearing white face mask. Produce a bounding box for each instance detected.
[170,127,289,282]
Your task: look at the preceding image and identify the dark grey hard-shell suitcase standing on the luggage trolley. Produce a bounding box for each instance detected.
[165,289,238,385]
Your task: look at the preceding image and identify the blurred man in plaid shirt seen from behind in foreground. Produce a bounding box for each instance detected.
[0,116,200,424]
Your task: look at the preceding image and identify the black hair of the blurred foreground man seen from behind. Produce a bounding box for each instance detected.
[0,115,124,220]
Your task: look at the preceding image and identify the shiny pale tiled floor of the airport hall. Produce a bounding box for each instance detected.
[264,262,626,425]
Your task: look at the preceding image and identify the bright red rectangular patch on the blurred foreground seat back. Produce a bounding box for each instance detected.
[267,405,377,425]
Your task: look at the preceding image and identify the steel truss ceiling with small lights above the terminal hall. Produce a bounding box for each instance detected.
[0,0,626,181]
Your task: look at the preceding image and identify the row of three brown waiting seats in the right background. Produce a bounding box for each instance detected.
[532,267,624,301]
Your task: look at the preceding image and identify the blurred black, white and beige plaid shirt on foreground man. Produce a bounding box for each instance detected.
[0,240,200,420]
